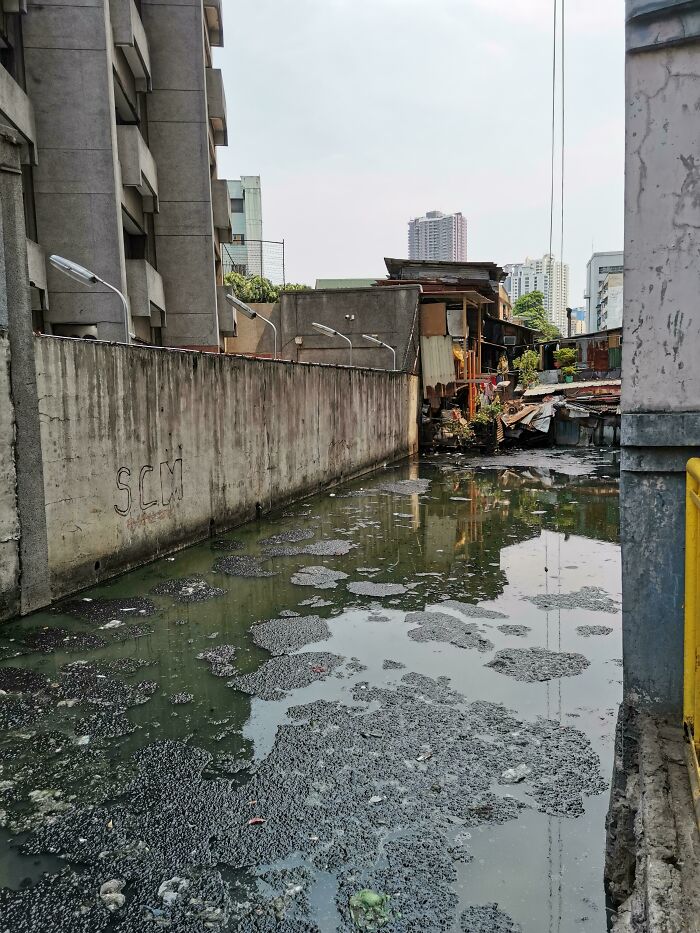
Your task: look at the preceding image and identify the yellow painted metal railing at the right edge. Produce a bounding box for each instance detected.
[683,458,700,744]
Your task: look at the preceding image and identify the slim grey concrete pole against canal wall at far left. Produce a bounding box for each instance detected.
[0,125,51,617]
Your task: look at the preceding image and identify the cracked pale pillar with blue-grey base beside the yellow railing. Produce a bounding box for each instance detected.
[621,0,700,721]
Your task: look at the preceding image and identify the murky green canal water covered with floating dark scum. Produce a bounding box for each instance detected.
[0,451,622,933]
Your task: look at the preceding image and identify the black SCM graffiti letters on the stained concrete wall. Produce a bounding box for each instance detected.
[114,457,184,524]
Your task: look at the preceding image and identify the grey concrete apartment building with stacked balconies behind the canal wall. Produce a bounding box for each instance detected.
[0,0,234,352]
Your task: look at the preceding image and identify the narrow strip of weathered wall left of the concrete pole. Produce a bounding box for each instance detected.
[0,331,20,619]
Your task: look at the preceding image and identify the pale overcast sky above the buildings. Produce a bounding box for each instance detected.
[217,0,624,306]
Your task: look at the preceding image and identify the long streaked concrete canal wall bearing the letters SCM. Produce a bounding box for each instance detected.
[36,337,419,598]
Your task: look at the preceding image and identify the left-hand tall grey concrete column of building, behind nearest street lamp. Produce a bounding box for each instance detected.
[23,0,126,341]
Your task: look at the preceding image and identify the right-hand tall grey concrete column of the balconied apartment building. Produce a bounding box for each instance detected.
[141,0,219,350]
